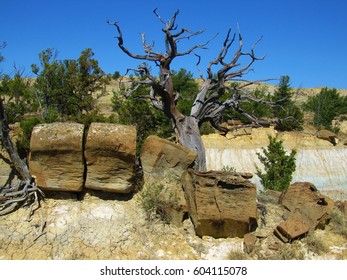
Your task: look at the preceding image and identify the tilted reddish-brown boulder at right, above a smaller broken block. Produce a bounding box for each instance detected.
[280,182,334,231]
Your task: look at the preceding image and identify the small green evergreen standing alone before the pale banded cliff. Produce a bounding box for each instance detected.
[256,136,296,191]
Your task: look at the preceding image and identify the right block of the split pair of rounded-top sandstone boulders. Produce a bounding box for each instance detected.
[85,123,136,193]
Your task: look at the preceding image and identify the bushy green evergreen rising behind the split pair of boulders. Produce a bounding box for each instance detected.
[32,49,110,119]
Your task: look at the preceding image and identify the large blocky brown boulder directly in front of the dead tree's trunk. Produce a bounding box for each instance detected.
[182,169,257,238]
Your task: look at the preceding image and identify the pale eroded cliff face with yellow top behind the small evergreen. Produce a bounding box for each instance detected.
[203,128,347,200]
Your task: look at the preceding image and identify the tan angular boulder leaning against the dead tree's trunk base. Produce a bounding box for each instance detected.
[141,136,197,180]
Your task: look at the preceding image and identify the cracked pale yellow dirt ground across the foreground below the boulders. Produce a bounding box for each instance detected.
[0,190,347,260]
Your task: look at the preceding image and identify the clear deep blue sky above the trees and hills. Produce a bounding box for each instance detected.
[0,0,347,89]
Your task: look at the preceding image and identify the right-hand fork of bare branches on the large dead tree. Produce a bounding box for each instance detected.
[191,26,279,128]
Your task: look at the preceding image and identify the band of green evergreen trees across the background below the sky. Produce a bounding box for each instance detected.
[0,46,347,156]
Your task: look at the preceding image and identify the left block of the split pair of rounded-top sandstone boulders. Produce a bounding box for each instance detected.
[29,123,84,192]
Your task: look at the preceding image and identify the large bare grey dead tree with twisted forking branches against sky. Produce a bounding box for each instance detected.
[109,10,280,171]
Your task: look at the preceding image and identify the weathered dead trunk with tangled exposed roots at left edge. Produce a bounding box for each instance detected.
[0,96,43,216]
